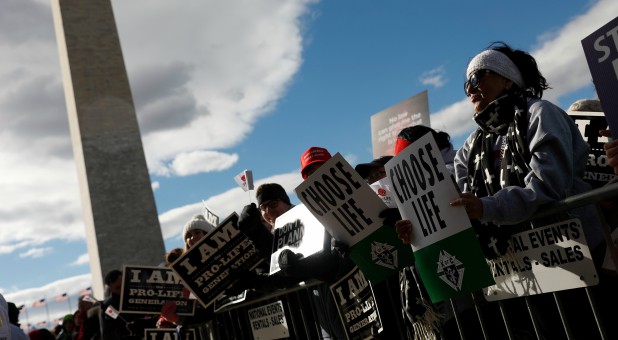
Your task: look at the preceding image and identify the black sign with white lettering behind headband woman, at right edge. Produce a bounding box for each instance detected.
[567,111,616,189]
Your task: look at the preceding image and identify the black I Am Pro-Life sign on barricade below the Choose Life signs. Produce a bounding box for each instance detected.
[330,267,382,340]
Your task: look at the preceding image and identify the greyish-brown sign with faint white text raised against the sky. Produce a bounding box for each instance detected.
[371,91,430,158]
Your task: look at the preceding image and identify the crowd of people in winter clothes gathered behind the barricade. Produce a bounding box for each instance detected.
[0,43,618,340]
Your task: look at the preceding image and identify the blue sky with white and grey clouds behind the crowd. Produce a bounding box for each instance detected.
[0,0,618,330]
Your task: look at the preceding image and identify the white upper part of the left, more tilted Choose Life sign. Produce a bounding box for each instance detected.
[294,153,386,247]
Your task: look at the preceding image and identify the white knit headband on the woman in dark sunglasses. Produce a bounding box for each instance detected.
[466,50,526,89]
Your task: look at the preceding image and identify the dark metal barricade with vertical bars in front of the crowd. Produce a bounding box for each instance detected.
[199,181,618,340]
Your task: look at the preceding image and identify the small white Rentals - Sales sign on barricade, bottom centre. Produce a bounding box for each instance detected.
[247,301,290,340]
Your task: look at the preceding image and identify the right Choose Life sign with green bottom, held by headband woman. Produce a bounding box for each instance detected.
[385,133,494,303]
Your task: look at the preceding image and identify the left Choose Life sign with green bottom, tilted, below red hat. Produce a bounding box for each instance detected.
[295,153,413,283]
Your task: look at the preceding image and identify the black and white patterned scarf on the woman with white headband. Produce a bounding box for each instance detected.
[468,93,531,260]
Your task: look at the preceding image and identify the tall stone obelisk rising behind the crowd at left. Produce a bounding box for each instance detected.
[52,0,165,298]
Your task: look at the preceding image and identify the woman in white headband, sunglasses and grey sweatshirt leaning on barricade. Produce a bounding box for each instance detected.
[451,43,604,336]
